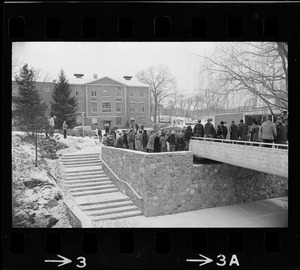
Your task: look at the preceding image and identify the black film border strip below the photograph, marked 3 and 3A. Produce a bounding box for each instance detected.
[4,229,300,269]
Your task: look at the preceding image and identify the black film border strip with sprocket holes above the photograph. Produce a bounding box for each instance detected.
[5,2,299,41]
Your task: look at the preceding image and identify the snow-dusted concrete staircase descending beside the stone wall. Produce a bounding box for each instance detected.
[62,152,142,221]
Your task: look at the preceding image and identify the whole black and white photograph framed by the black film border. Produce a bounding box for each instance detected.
[11,41,292,228]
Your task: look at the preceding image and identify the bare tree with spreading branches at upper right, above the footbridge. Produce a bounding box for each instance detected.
[195,42,288,114]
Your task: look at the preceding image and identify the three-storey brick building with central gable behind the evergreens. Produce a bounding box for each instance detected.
[12,75,151,129]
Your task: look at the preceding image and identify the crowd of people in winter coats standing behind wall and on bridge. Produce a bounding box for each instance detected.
[98,116,287,152]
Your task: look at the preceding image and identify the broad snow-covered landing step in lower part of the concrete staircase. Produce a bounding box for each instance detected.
[76,192,130,206]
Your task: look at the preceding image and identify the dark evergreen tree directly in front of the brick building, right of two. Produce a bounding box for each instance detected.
[50,69,78,128]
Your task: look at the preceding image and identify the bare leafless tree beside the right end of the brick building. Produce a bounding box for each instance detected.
[136,65,176,125]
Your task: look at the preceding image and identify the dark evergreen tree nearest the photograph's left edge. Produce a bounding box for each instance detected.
[12,64,47,132]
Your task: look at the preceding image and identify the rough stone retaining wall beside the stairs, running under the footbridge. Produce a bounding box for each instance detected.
[102,146,287,217]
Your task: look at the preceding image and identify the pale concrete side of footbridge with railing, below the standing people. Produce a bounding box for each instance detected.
[189,137,288,177]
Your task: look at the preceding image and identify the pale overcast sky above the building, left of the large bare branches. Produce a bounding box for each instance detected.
[12,42,215,92]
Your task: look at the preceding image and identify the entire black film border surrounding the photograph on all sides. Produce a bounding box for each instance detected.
[3,2,300,269]
